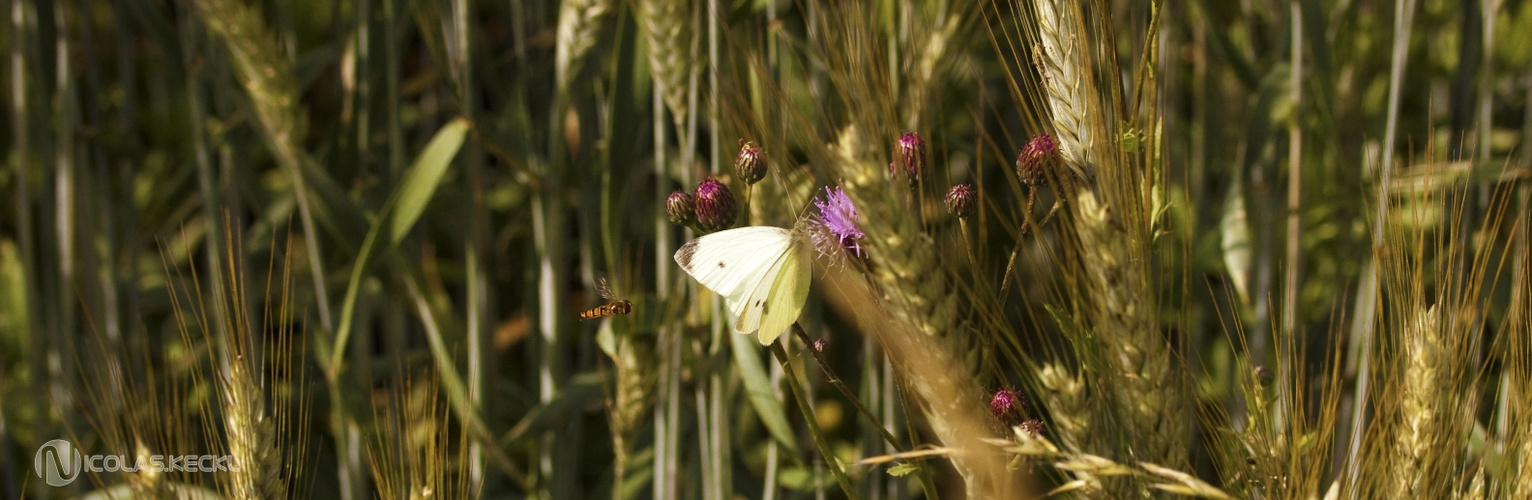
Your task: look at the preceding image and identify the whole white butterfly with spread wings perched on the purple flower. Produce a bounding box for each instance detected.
[676,225,813,345]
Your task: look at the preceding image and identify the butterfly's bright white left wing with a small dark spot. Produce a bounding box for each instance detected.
[676,225,791,305]
